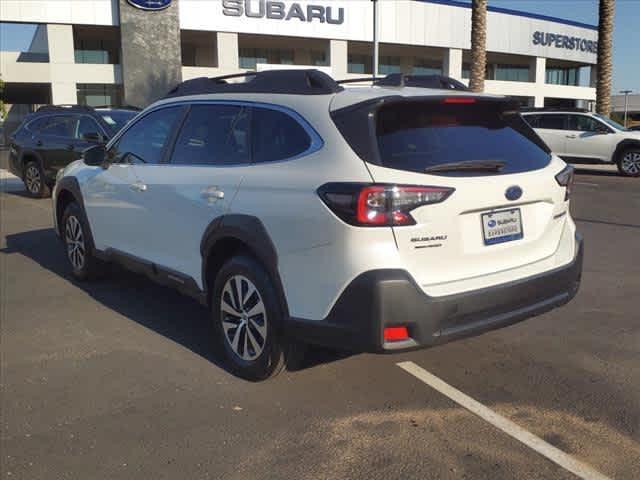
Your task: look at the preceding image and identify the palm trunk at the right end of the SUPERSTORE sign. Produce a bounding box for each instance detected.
[596,0,616,116]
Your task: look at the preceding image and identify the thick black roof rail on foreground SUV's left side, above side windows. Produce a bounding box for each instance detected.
[165,69,344,98]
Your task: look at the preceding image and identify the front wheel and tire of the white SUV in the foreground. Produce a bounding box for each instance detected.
[59,203,104,281]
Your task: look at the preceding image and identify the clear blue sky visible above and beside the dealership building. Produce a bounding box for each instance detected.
[0,0,640,94]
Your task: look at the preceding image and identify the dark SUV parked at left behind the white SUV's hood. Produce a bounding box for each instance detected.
[9,105,138,198]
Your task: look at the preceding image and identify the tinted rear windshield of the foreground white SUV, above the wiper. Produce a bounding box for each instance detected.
[377,102,550,174]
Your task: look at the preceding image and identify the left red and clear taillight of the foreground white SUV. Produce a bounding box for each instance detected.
[318,183,454,227]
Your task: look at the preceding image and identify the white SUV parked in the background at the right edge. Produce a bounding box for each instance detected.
[522,109,640,177]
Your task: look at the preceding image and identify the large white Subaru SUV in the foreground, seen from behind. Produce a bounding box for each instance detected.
[53,70,582,380]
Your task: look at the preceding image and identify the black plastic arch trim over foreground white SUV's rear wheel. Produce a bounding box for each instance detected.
[200,214,289,318]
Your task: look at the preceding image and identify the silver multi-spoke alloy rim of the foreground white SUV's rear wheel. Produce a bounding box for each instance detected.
[220,275,267,361]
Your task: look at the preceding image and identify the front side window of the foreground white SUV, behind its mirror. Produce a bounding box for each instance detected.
[109,107,182,163]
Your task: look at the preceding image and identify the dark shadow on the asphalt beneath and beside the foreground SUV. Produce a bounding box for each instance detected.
[0,228,352,373]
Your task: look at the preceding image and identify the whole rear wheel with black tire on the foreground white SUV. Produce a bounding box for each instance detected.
[210,255,285,381]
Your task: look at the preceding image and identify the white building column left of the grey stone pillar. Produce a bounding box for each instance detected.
[47,24,78,104]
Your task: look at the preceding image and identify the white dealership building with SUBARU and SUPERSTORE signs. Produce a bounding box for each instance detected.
[0,0,598,114]
